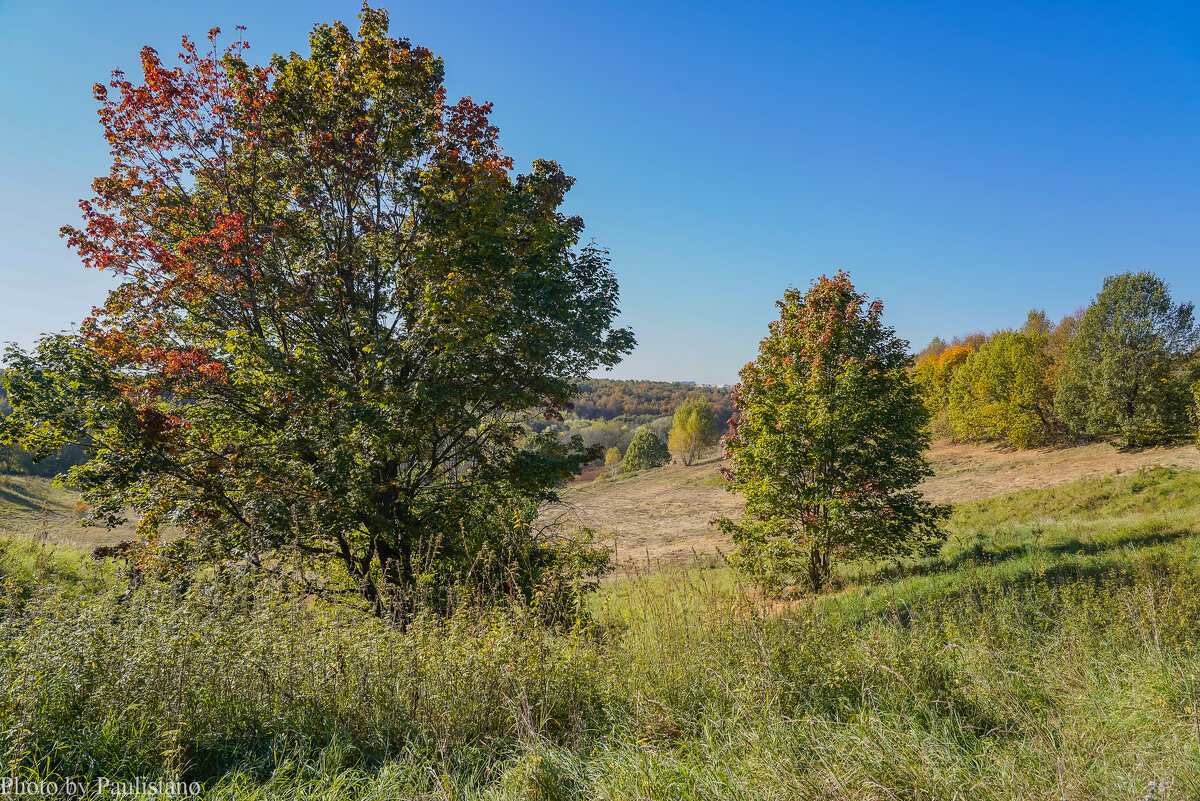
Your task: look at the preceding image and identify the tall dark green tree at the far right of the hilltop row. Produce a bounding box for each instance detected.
[1055,272,1198,446]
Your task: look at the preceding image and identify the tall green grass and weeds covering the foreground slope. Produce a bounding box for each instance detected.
[0,453,1200,800]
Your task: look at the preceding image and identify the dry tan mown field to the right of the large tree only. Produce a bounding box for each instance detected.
[544,442,1200,571]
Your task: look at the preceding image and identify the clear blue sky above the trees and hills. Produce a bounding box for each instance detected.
[0,0,1200,383]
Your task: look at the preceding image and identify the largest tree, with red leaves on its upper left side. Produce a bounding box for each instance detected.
[5,6,634,615]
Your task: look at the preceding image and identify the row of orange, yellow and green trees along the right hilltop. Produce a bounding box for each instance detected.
[913,272,1200,448]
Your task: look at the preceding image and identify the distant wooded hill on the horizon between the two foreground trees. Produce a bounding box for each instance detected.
[575,378,733,427]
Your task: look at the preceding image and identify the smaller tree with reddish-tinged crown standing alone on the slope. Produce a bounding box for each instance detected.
[718,272,947,591]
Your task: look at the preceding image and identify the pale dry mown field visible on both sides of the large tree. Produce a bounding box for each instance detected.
[9,442,1200,563]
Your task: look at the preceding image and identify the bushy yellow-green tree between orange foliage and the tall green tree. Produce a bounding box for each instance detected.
[947,328,1056,447]
